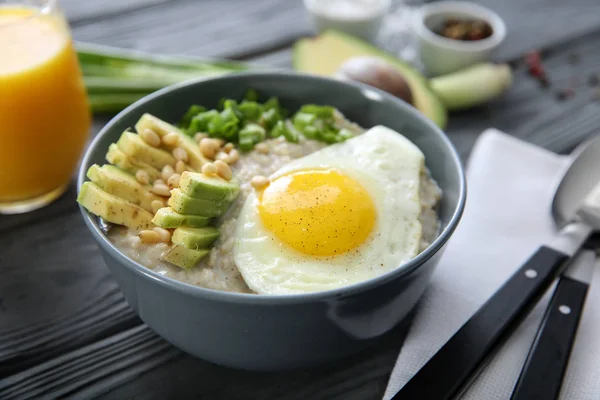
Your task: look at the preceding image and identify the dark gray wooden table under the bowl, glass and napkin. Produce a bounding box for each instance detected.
[0,0,600,400]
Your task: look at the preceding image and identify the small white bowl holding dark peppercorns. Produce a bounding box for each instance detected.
[412,1,506,76]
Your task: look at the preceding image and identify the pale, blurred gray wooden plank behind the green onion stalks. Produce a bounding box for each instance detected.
[73,0,310,58]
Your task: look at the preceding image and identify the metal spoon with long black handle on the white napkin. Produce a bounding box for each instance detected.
[393,137,600,400]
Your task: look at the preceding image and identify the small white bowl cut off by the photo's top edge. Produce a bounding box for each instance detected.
[304,0,391,42]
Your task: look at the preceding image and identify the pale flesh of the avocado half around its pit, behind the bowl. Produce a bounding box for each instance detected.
[293,30,448,128]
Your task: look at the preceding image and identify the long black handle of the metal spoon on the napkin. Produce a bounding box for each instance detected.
[393,246,569,400]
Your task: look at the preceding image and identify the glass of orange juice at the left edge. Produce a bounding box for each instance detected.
[0,0,90,214]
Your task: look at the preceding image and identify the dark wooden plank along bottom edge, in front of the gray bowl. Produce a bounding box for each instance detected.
[0,321,408,400]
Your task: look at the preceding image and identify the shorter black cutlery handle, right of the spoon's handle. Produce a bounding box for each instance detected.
[511,276,589,400]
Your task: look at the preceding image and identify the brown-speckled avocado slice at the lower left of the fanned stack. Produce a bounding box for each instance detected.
[77,182,152,231]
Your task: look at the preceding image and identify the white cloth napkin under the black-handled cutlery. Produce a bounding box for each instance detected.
[384,129,600,400]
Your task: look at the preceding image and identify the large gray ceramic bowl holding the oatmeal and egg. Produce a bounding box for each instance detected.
[78,72,465,370]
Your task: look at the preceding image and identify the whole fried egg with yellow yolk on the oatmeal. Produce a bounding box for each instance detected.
[234,126,425,294]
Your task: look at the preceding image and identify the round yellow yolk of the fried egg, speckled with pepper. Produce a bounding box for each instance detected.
[258,170,376,256]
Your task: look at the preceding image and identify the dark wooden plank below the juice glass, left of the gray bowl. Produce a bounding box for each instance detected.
[0,183,140,378]
